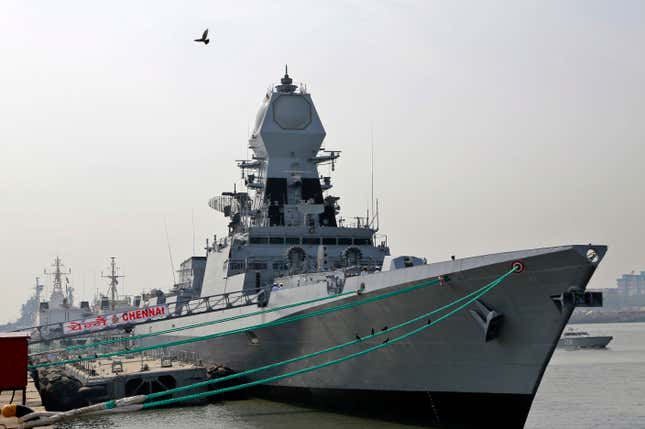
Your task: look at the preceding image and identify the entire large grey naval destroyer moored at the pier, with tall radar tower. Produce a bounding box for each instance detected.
[135,68,606,427]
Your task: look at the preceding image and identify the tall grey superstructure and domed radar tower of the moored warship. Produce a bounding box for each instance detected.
[202,67,389,294]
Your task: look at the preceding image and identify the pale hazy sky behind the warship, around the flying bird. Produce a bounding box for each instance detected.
[0,0,645,322]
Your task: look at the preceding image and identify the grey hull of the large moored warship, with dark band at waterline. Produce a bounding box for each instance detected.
[136,242,606,427]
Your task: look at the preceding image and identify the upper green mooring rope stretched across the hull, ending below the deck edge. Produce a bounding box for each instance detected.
[28,279,440,369]
